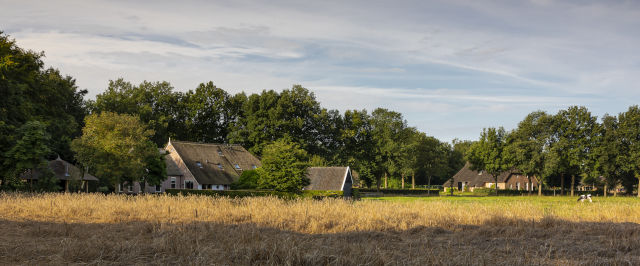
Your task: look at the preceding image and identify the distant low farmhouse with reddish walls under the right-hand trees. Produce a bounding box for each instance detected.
[442,162,538,191]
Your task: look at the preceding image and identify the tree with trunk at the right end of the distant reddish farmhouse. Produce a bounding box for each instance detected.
[505,111,551,196]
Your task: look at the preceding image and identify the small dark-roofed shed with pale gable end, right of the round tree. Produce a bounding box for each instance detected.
[304,166,353,197]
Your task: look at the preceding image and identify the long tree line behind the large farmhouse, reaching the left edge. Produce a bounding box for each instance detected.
[0,32,470,189]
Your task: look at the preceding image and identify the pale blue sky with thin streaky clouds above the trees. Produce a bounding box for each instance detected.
[0,0,640,141]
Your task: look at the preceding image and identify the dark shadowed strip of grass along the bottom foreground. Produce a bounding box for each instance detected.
[0,218,640,265]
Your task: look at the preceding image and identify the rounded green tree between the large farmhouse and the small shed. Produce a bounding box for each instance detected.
[257,138,309,192]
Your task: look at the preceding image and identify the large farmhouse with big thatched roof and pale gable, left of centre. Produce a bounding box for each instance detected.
[120,140,262,193]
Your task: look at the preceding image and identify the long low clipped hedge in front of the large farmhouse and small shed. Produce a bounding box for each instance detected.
[165,189,343,199]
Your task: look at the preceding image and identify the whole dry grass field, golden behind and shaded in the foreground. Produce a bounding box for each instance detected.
[0,194,640,265]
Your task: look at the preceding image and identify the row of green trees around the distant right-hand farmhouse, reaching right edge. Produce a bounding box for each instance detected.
[466,105,640,196]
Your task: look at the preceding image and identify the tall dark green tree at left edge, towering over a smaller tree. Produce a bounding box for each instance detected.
[0,31,87,168]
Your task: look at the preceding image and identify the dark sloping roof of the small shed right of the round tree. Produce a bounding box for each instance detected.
[304,166,349,190]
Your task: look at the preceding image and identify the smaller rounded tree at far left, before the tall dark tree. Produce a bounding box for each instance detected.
[2,121,51,188]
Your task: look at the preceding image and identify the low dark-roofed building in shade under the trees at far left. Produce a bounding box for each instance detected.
[20,156,98,192]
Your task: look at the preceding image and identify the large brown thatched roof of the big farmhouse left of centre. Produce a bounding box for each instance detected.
[169,141,262,185]
